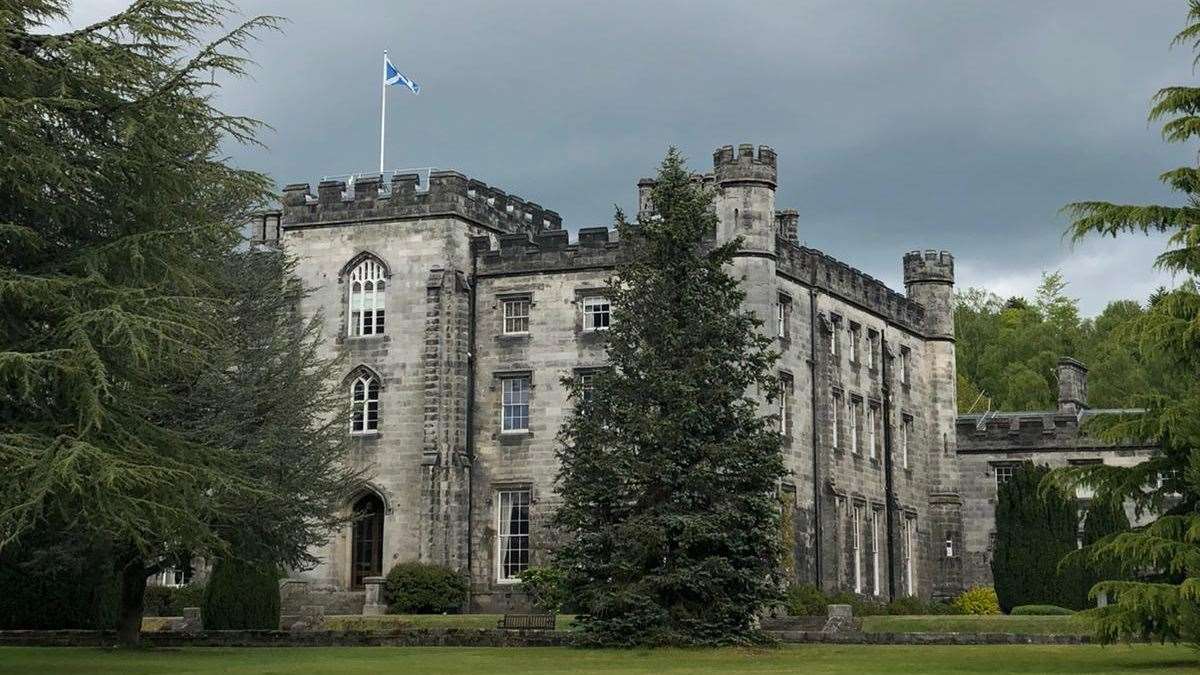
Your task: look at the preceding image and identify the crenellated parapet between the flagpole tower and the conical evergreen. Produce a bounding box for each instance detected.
[470,227,625,276]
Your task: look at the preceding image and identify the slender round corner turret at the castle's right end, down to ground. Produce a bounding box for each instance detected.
[904,251,964,597]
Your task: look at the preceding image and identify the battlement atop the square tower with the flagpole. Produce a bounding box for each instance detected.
[282,171,563,234]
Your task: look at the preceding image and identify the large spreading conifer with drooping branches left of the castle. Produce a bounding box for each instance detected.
[0,0,353,644]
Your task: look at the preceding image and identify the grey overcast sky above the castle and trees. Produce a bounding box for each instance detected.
[56,0,1194,313]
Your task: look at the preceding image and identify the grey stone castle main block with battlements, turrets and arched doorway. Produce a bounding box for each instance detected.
[254,145,964,611]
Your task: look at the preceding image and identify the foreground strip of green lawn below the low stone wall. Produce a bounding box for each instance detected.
[0,645,1200,675]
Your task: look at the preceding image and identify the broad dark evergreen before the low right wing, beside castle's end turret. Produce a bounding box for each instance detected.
[991,462,1079,614]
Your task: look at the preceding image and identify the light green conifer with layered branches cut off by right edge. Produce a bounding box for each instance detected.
[1054,0,1200,644]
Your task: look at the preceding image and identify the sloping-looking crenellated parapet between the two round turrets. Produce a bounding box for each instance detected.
[775,238,925,335]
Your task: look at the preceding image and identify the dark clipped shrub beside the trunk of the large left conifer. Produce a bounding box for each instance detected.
[200,558,282,631]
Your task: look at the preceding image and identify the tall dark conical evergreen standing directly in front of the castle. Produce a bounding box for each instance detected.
[554,149,784,645]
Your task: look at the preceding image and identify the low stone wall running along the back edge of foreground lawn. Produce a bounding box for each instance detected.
[0,628,1091,647]
